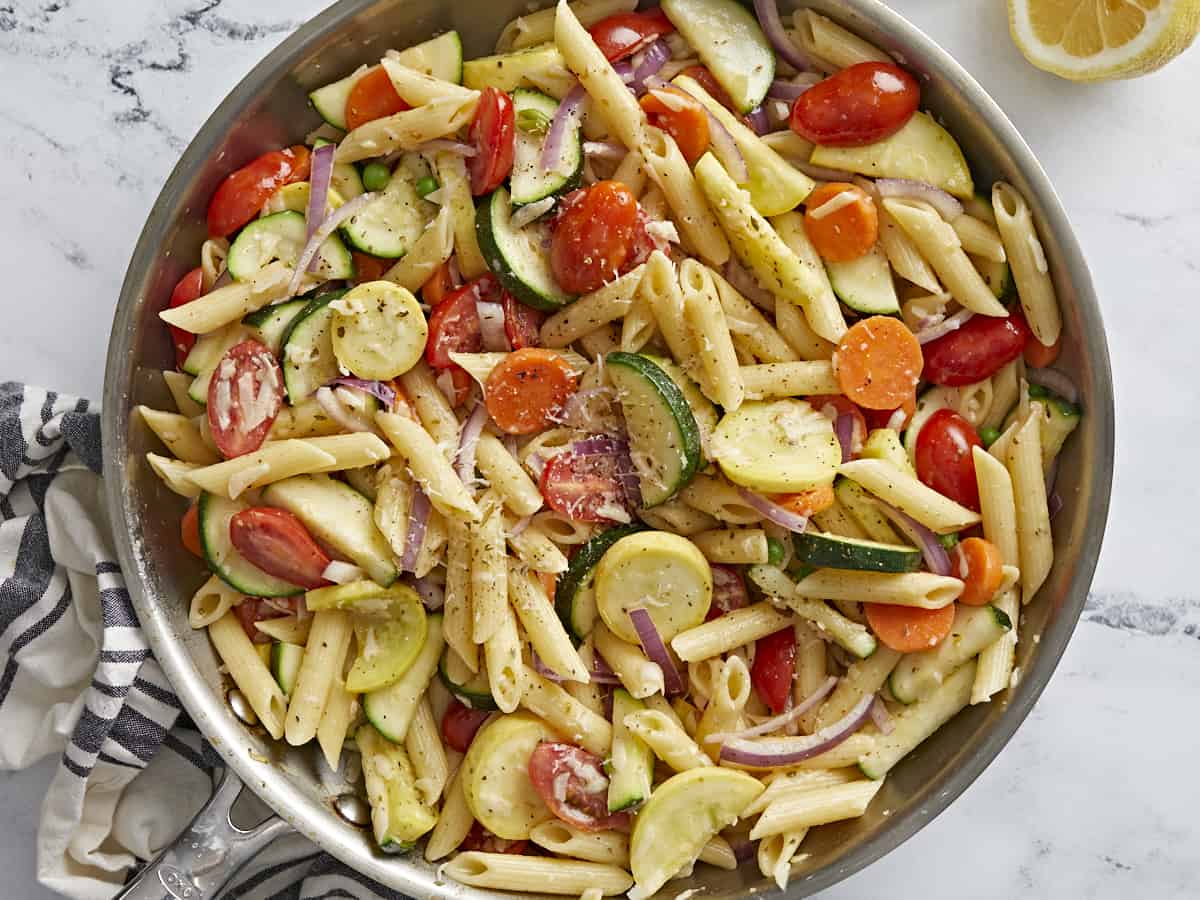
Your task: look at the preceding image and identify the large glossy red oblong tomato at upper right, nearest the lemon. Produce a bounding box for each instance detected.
[791,62,920,146]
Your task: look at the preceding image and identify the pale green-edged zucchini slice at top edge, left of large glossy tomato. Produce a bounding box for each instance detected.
[662,0,775,113]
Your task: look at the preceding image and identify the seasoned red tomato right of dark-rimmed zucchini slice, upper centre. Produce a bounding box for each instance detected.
[550,181,638,294]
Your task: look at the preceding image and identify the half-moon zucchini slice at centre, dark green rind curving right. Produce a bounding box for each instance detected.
[605,352,700,506]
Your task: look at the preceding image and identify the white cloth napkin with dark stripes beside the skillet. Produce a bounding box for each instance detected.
[0,383,403,900]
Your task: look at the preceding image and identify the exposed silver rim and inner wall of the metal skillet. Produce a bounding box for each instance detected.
[103,0,1114,900]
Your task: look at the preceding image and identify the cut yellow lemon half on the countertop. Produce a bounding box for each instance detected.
[1008,0,1200,82]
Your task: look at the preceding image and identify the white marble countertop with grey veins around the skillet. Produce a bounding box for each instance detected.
[0,0,1200,900]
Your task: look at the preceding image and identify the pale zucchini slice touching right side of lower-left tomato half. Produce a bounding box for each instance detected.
[263,475,400,587]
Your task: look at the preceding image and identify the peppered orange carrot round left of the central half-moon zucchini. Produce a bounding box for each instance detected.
[484,347,577,434]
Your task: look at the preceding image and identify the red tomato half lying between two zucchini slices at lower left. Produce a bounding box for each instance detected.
[229,506,329,590]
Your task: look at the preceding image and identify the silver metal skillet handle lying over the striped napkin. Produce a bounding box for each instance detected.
[114,768,292,900]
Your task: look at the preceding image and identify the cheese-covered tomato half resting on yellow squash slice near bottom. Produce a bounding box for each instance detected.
[529,740,629,832]
